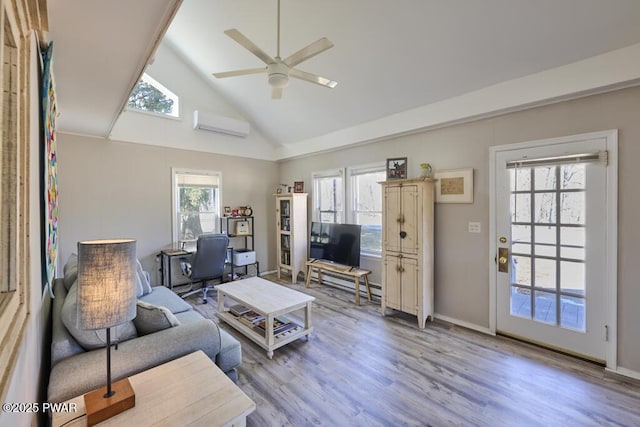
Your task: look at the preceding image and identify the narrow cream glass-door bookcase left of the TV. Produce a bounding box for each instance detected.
[276,193,308,283]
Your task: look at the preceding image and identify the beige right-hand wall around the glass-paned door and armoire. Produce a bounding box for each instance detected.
[280,87,640,372]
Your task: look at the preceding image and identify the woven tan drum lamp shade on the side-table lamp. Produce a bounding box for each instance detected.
[77,239,136,330]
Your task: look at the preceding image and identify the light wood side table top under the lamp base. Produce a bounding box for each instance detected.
[52,351,256,427]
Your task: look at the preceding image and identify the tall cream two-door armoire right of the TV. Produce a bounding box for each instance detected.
[381,178,435,328]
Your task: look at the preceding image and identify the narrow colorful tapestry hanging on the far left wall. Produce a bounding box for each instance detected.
[41,42,58,292]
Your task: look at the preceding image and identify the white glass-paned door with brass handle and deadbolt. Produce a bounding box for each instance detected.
[492,133,617,362]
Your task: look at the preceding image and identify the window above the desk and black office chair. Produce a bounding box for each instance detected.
[173,168,222,249]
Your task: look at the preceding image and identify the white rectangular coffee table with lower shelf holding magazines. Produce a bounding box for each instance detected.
[215,277,315,359]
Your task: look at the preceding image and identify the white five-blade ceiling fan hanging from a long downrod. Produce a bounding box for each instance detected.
[213,0,338,99]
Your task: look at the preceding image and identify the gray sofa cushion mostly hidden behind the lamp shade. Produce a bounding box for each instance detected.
[61,282,137,350]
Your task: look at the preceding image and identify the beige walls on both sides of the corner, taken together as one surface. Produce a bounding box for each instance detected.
[58,88,640,372]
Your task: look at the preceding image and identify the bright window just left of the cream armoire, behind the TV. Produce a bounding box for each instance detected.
[349,163,386,256]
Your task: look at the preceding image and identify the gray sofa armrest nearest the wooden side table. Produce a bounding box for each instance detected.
[47,319,220,402]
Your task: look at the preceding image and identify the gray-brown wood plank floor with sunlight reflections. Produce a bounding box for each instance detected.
[187,276,640,427]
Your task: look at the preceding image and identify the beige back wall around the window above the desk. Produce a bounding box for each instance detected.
[58,134,278,283]
